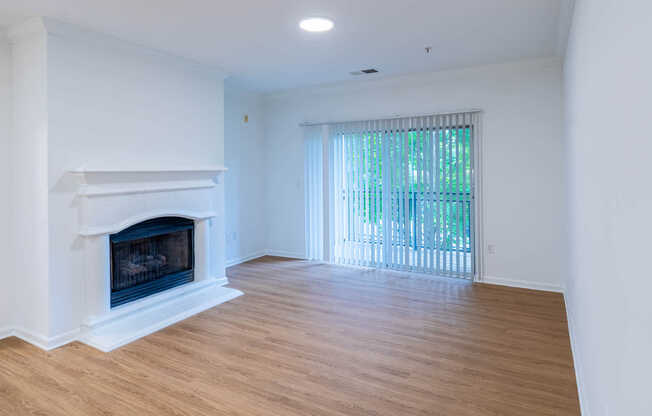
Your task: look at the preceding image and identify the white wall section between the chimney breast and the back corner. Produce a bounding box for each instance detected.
[224,80,269,265]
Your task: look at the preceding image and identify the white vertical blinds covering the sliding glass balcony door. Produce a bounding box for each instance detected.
[306,112,479,278]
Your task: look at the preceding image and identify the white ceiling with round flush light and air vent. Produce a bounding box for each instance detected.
[0,0,570,91]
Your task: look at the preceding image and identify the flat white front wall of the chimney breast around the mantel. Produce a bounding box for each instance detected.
[48,24,224,334]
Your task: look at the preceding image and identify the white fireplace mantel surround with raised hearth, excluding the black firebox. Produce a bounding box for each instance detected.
[70,166,242,351]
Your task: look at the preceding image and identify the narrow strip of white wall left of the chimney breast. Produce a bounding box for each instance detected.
[0,31,13,333]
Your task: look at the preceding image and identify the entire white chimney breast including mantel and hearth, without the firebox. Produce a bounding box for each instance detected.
[0,18,234,351]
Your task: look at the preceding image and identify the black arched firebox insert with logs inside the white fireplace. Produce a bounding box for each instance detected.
[110,217,195,308]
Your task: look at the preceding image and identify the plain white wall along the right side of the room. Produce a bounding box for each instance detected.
[564,0,652,416]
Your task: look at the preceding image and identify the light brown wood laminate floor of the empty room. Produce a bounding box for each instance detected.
[0,257,579,416]
